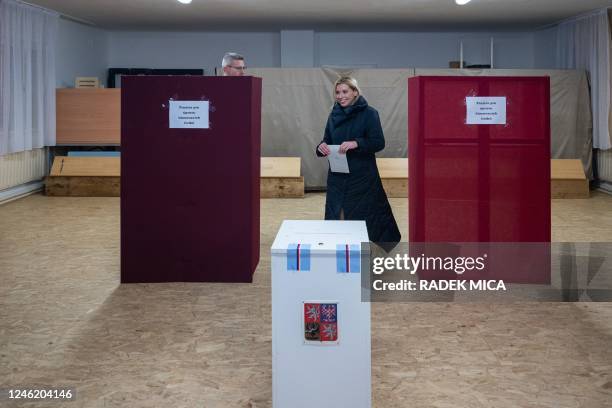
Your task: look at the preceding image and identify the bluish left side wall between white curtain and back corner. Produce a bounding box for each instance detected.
[55,18,109,88]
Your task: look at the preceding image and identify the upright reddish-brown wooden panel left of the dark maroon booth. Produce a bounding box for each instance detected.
[56,88,121,145]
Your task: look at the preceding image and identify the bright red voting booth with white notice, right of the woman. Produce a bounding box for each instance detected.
[408,76,551,283]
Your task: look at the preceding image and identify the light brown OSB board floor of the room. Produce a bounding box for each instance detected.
[0,193,612,408]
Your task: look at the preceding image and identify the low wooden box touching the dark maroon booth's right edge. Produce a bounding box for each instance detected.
[260,157,304,198]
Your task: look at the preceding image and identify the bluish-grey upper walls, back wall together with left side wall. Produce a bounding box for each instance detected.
[57,26,556,86]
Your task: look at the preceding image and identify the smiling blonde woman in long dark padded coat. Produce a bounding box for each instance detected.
[316,77,401,247]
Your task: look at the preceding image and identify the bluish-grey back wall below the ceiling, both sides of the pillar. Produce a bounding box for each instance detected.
[104,31,535,74]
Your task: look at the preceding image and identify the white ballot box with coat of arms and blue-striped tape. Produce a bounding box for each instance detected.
[272,221,371,408]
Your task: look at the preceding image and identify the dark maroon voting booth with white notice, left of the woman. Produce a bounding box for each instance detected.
[121,76,261,282]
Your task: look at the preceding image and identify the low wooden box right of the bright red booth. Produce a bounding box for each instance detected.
[550,159,589,198]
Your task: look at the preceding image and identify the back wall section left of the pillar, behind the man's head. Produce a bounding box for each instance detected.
[109,31,280,75]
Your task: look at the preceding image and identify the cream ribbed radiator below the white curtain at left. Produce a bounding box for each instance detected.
[0,148,47,191]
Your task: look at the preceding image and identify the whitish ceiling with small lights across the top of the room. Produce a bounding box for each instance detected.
[25,0,612,31]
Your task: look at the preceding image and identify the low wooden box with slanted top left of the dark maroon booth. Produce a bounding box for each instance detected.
[45,156,121,197]
